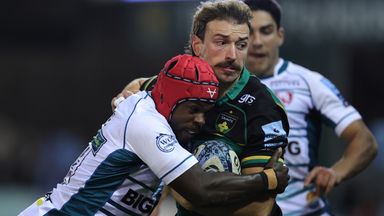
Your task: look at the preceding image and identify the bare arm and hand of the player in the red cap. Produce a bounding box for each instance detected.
[170,149,289,210]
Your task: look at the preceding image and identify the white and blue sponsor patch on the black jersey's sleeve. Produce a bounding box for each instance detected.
[261,121,287,148]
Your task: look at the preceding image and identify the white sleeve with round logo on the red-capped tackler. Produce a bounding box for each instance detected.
[126,110,198,184]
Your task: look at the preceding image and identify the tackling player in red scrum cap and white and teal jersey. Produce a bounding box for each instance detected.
[20,55,289,216]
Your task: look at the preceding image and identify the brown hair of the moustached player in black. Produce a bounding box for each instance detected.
[185,0,252,55]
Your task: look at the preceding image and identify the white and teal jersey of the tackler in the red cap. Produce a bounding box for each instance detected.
[21,92,197,216]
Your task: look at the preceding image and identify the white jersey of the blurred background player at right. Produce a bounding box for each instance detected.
[261,59,361,216]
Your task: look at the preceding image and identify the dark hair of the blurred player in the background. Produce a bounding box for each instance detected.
[244,0,281,28]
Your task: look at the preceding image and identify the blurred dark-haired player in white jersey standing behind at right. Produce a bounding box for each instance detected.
[245,0,378,215]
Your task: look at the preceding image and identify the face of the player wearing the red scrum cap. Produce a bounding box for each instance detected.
[169,101,214,145]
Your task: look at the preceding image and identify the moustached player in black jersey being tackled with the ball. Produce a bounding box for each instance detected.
[112,0,289,215]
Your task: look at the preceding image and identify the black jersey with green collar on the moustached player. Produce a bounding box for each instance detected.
[199,69,289,168]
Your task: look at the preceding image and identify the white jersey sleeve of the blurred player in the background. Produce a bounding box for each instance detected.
[307,72,361,136]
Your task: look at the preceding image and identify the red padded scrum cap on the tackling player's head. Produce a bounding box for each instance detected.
[151,54,219,121]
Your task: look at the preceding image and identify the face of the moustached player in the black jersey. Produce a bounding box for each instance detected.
[191,20,250,91]
